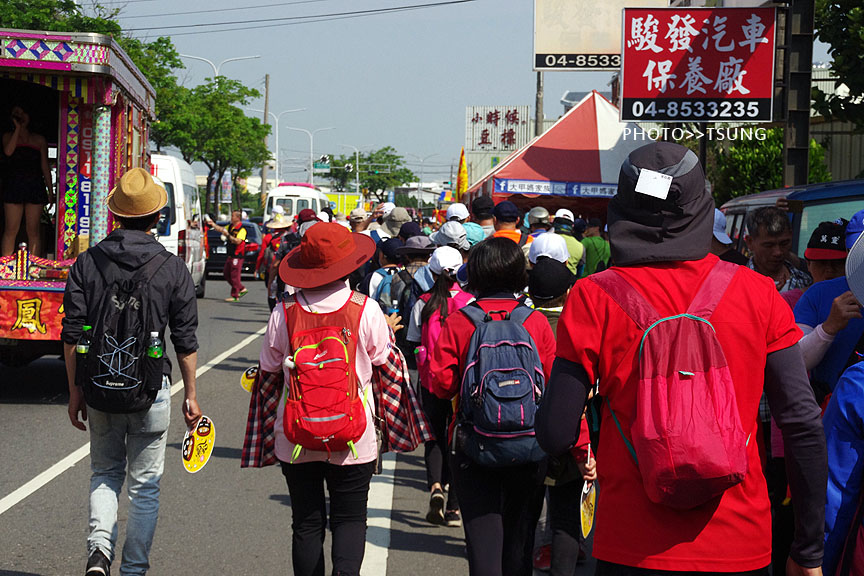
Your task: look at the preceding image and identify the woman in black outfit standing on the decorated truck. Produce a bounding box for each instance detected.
[0,105,54,256]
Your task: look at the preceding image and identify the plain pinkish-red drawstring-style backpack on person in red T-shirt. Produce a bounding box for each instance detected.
[589,260,749,509]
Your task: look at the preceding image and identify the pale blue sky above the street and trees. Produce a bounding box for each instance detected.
[111,0,827,181]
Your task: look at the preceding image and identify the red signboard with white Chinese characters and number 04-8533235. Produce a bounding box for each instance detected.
[621,8,776,122]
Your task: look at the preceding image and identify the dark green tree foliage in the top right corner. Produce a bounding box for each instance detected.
[812,0,864,131]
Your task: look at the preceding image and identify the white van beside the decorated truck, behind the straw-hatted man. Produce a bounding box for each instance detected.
[150,154,207,298]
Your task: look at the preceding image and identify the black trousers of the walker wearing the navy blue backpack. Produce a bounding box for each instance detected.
[451,452,545,576]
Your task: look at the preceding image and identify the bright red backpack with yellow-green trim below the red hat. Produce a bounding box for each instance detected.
[282,292,366,462]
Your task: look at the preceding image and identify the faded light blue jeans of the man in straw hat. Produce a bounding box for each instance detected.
[87,376,171,576]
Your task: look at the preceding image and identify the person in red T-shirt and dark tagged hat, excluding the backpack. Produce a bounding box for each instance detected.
[535,142,826,576]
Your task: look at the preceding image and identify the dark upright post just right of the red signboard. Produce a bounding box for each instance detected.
[783,0,815,186]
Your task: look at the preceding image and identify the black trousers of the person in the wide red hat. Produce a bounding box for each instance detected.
[282,461,375,576]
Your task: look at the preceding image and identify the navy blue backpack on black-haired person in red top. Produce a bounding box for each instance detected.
[457,302,546,467]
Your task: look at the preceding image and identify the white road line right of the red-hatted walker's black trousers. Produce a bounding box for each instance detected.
[362,452,396,574]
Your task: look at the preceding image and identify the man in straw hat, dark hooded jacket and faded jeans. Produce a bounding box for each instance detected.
[62,168,201,576]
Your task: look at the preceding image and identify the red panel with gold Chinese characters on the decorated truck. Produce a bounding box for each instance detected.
[0,290,63,341]
